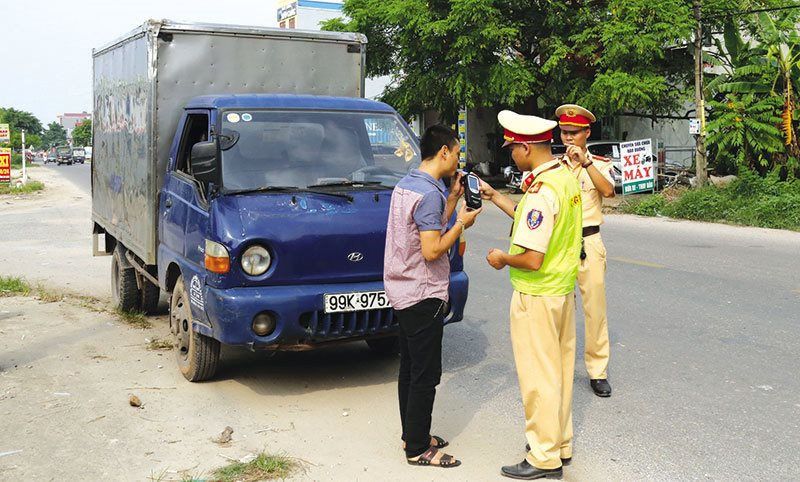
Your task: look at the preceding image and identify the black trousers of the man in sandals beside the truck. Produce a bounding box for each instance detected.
[395,298,446,458]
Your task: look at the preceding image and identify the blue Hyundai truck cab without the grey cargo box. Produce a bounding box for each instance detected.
[158,94,468,380]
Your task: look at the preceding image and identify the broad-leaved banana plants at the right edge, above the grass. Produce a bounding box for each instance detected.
[706,6,800,174]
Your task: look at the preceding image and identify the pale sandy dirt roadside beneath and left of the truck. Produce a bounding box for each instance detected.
[0,168,522,480]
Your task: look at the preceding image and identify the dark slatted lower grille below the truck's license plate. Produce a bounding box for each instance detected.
[300,308,397,339]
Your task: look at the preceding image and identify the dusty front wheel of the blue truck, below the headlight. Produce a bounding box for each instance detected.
[169,276,219,382]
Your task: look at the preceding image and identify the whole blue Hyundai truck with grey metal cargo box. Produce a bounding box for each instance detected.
[92,21,468,381]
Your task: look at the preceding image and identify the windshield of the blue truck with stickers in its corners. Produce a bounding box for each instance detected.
[220,111,420,191]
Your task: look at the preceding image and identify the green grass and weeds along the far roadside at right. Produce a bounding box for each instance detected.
[620,171,800,231]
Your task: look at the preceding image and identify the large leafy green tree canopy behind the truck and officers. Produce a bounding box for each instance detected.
[324,0,771,119]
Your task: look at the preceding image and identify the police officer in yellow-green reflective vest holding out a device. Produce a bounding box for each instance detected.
[481,110,581,479]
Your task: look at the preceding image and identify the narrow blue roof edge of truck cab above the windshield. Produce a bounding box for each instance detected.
[186,94,395,113]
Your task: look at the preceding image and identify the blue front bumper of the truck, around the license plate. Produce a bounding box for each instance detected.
[195,271,469,351]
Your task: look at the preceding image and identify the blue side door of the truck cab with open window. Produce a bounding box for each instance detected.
[159,110,209,259]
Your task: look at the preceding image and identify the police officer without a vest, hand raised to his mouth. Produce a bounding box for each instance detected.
[556,104,614,397]
